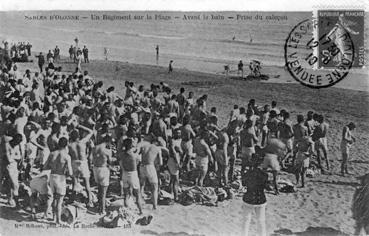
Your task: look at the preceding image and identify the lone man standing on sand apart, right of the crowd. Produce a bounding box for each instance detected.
[341,122,356,176]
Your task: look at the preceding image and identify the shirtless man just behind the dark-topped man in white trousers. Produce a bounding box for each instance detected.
[240,120,259,175]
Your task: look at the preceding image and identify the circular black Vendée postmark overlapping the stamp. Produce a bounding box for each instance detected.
[284,20,354,89]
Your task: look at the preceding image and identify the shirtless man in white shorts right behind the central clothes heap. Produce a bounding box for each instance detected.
[193,131,213,187]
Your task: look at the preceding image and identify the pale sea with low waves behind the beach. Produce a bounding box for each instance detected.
[0,11,369,91]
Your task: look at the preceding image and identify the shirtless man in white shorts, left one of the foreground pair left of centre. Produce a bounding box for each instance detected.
[118,138,142,214]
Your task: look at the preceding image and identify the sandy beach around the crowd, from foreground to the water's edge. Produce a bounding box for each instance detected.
[0,55,369,235]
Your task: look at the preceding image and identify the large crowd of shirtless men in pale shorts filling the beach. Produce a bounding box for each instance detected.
[0,61,355,226]
